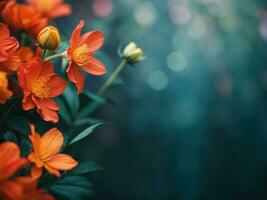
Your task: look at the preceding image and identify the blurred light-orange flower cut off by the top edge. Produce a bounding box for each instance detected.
[27,0,71,19]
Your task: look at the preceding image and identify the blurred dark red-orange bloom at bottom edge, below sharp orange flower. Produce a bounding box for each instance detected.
[15,177,54,200]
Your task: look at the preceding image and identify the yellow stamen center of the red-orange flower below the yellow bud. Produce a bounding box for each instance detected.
[32,76,50,99]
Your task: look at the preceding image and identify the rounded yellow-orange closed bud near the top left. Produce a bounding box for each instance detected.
[37,26,60,50]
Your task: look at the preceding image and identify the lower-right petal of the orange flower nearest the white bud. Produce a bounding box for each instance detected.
[82,58,107,75]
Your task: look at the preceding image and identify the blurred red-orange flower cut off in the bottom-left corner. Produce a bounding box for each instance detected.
[0,142,28,200]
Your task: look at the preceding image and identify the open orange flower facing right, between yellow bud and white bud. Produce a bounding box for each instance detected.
[67,20,107,93]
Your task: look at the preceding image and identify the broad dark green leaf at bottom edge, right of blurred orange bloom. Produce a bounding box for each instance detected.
[46,176,94,200]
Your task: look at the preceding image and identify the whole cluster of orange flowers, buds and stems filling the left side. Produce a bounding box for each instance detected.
[0,0,143,200]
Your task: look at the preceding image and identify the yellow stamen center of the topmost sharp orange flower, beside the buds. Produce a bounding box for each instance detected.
[73,44,91,66]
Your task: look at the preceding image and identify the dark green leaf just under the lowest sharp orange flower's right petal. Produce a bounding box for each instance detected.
[71,161,104,175]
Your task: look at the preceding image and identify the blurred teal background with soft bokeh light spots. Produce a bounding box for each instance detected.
[56,0,267,200]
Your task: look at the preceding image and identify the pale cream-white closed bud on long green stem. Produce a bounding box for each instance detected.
[121,42,145,64]
